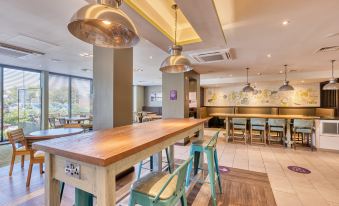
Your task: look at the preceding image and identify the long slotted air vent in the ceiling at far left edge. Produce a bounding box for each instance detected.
[0,42,45,58]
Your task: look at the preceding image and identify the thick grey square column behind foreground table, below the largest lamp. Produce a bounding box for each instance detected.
[93,46,133,130]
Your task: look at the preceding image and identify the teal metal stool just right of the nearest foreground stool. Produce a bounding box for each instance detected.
[186,131,222,206]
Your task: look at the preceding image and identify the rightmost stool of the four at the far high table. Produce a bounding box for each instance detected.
[292,119,313,151]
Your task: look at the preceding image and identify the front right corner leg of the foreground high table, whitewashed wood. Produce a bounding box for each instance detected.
[95,166,116,206]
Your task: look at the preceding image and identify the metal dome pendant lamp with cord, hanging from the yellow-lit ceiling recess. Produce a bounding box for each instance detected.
[160,4,193,73]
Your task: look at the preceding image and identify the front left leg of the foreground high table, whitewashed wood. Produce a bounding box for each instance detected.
[45,153,60,206]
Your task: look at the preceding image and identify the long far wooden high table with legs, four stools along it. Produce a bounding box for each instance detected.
[209,113,320,147]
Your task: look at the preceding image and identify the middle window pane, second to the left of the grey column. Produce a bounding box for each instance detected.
[48,74,70,118]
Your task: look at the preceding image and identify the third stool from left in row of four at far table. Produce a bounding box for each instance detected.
[267,119,286,144]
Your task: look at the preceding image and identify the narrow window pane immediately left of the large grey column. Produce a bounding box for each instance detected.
[71,77,92,116]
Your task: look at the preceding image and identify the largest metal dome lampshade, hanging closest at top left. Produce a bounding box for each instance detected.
[68,0,140,49]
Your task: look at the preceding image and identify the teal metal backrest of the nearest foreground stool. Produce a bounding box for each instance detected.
[154,156,193,203]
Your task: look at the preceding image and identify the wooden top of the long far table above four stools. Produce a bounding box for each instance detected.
[209,113,320,119]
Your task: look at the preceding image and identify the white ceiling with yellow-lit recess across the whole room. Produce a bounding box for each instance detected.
[0,0,339,86]
